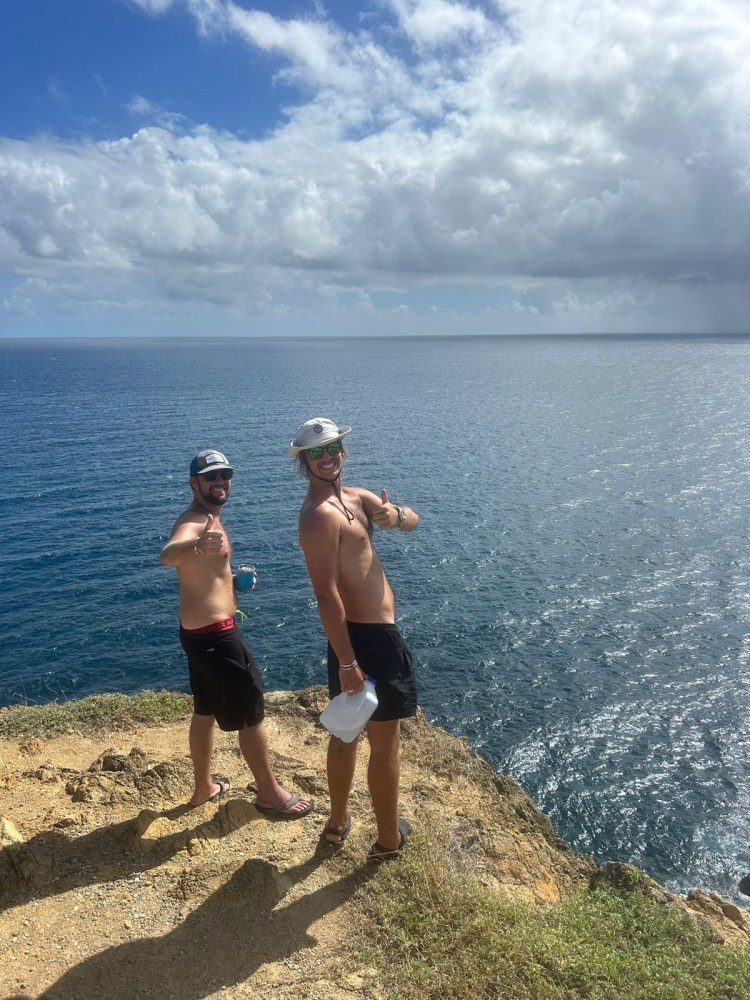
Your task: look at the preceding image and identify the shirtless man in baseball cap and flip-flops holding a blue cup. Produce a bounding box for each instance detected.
[161,449,312,819]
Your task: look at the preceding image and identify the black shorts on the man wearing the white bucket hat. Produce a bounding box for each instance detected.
[328,622,417,722]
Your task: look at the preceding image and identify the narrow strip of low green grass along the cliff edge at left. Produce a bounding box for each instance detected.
[0,691,192,738]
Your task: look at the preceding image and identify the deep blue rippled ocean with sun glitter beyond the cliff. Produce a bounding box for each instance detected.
[0,336,750,905]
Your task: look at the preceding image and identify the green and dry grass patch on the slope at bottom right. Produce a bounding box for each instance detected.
[360,837,750,1000]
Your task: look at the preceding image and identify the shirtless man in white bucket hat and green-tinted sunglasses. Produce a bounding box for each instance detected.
[289,417,419,861]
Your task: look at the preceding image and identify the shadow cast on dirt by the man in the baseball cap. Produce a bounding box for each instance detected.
[0,798,266,910]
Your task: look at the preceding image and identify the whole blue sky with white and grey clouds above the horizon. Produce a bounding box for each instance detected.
[0,0,750,337]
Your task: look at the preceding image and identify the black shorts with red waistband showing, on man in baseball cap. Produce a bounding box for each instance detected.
[180,625,264,732]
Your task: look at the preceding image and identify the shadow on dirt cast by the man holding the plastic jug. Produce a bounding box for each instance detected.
[30,857,368,1000]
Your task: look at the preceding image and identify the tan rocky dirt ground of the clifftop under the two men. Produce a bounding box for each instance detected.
[0,689,750,1000]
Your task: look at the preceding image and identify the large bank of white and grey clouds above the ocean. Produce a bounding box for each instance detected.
[0,0,750,336]
